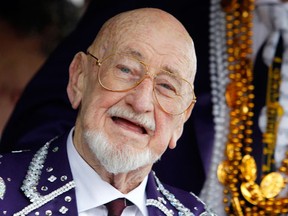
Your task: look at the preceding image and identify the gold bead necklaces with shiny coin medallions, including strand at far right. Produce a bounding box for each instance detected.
[217,0,288,216]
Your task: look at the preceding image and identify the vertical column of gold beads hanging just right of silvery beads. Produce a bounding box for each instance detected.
[218,0,256,215]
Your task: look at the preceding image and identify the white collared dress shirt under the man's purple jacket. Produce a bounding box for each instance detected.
[67,129,148,216]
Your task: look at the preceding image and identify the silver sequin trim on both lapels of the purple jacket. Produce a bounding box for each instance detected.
[14,137,215,216]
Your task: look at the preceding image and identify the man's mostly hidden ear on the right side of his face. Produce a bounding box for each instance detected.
[169,104,194,149]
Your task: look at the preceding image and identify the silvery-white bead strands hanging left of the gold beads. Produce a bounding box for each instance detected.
[200,0,229,215]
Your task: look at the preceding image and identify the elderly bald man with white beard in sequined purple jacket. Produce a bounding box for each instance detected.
[0,8,213,216]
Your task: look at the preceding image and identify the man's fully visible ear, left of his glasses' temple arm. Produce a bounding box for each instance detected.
[67,52,87,109]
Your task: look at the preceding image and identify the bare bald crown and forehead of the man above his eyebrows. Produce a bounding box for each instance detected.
[89,8,196,81]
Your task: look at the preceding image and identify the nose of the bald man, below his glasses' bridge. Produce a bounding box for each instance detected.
[126,76,155,113]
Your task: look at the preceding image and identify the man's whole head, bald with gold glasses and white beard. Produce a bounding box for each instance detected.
[67,8,196,178]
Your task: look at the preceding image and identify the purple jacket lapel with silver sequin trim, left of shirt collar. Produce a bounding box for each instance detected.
[16,134,78,216]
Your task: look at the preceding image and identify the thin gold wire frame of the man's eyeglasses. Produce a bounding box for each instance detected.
[86,50,197,115]
